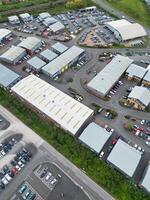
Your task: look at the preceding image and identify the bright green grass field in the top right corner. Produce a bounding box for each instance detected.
[107,0,150,26]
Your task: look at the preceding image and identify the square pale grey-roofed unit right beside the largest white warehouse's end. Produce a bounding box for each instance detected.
[79,122,111,154]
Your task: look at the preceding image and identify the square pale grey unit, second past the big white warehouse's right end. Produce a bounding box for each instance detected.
[107,139,142,177]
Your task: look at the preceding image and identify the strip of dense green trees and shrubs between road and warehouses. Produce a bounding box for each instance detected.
[0,89,149,200]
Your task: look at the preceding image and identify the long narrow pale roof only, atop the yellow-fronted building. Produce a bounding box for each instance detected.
[42,46,84,76]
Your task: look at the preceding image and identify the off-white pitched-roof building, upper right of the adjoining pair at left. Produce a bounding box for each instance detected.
[18,37,41,50]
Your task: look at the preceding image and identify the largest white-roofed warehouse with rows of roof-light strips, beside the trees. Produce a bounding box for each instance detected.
[12,74,94,135]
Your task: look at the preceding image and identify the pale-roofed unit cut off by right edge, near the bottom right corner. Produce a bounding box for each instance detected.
[140,163,150,192]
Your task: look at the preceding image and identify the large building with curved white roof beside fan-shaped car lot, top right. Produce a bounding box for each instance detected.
[106,19,147,42]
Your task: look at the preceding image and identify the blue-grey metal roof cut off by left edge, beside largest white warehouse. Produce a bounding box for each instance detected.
[0,64,20,87]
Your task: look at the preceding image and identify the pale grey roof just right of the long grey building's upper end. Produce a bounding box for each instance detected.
[126,64,147,79]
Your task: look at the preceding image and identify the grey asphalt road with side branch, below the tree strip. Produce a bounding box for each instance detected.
[0,106,114,200]
